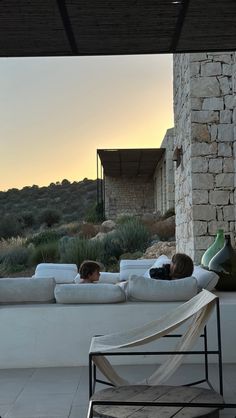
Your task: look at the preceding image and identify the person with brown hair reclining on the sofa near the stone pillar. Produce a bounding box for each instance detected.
[149,253,193,280]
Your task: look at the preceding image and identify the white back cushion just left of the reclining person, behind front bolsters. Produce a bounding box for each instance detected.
[120,258,155,281]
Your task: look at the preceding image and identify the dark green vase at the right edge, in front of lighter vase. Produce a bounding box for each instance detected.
[209,235,236,291]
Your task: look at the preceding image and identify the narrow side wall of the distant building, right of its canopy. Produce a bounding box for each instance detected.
[154,129,175,214]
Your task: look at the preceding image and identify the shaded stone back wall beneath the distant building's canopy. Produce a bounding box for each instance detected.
[105,176,154,219]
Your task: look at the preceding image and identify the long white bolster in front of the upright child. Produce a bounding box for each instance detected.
[55,283,126,303]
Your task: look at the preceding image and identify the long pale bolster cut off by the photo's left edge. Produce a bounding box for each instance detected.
[0,277,56,303]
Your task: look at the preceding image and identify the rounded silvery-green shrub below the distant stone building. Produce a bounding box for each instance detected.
[117,218,150,253]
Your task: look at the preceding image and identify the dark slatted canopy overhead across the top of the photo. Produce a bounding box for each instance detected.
[0,0,236,57]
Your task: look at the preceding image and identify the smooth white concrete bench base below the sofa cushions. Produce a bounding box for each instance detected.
[0,292,236,368]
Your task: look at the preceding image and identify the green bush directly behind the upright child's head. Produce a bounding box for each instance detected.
[59,237,103,266]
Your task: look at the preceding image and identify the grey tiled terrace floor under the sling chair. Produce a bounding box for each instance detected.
[0,364,236,418]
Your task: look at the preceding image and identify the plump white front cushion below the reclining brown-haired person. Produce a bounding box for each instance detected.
[127,276,198,302]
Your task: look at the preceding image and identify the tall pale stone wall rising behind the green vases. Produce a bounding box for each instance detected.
[174,52,236,262]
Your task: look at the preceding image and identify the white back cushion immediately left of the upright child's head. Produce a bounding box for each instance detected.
[33,263,78,283]
